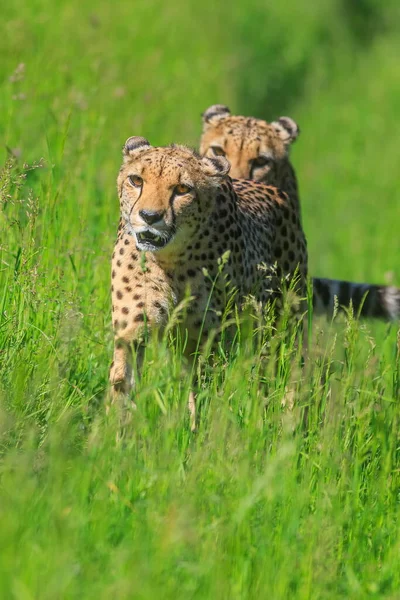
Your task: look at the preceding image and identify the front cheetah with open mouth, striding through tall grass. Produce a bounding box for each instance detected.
[110,137,307,398]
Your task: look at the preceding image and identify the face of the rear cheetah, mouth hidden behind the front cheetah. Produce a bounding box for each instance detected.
[200,104,299,183]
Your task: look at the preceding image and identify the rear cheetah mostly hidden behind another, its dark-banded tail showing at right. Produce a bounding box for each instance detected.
[200,104,400,320]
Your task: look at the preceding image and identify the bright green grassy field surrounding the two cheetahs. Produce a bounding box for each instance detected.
[0,0,400,600]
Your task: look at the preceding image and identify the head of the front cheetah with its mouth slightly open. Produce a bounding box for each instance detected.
[118,137,230,252]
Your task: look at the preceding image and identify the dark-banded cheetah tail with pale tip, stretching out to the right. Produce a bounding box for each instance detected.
[312,277,400,321]
